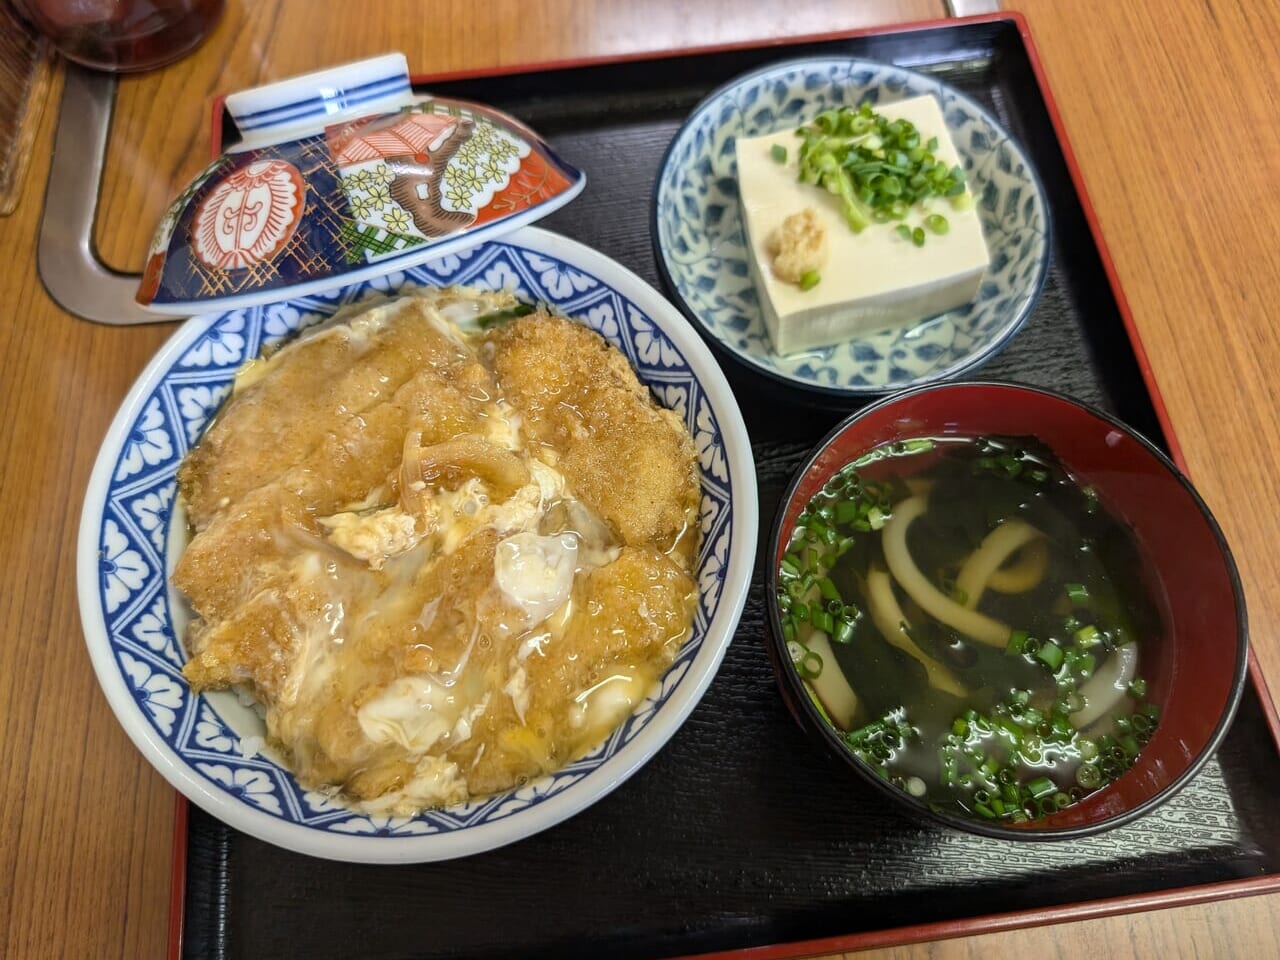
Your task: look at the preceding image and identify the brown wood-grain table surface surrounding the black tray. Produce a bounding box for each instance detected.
[0,0,1280,960]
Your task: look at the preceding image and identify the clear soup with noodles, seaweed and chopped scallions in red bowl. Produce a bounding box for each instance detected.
[778,436,1161,823]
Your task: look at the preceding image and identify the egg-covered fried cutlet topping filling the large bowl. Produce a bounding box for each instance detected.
[174,289,699,814]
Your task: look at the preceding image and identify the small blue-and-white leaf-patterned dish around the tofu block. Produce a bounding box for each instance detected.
[653,58,1050,399]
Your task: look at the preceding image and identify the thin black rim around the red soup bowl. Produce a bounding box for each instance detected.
[764,380,1249,841]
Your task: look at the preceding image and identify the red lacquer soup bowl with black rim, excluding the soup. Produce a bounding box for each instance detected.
[765,383,1248,840]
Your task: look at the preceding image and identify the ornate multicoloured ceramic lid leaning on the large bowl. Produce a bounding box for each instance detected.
[137,54,586,314]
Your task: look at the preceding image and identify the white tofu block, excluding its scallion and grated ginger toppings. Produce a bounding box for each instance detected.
[736,96,989,353]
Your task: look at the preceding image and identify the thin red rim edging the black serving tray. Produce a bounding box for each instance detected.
[177,10,1280,960]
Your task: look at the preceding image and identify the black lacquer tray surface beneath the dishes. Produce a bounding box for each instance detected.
[172,15,1280,960]
